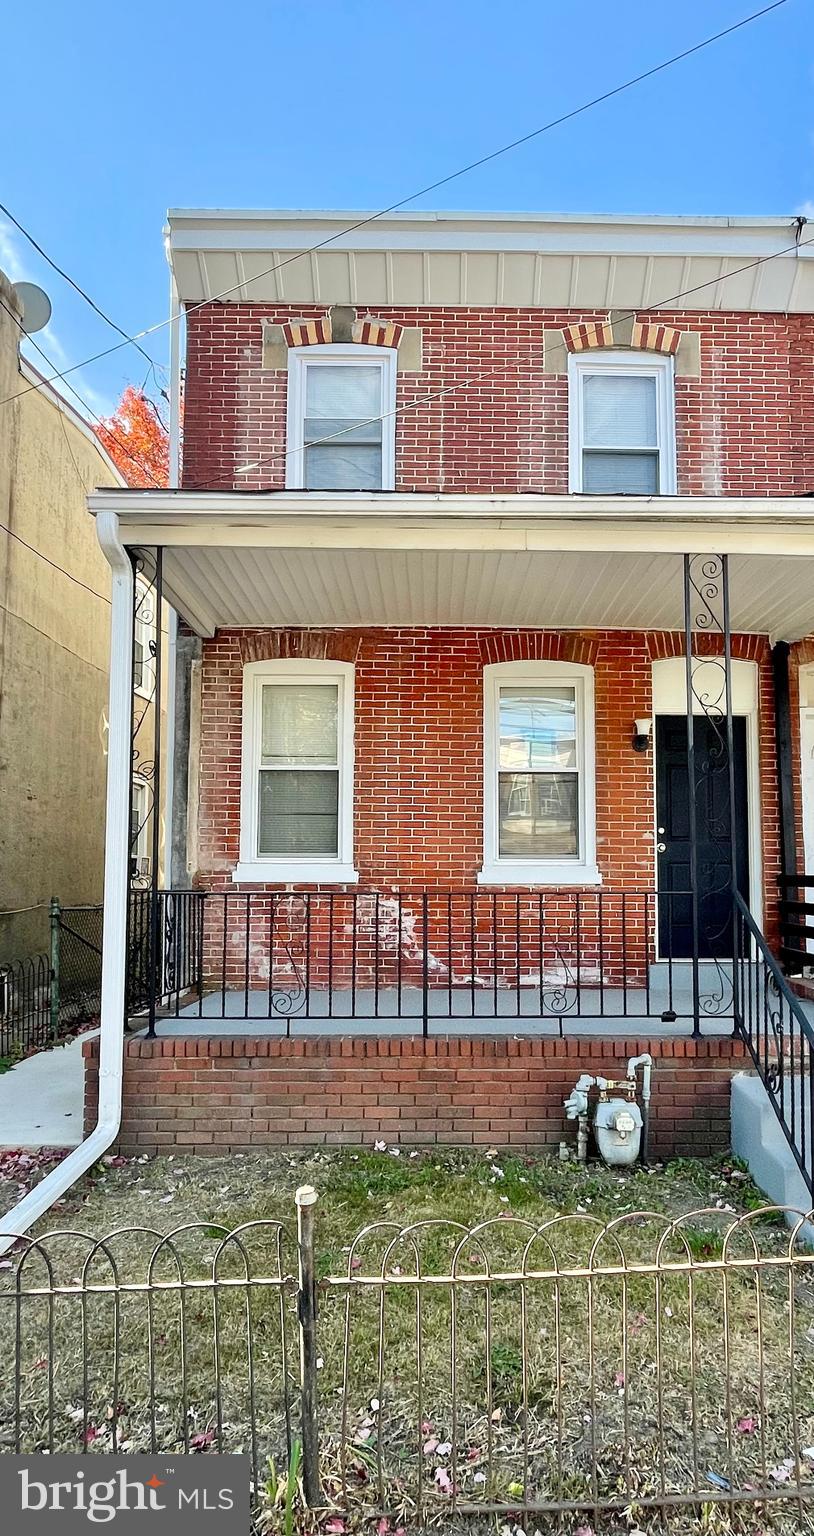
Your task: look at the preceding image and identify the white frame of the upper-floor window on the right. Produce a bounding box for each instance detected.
[568,350,676,496]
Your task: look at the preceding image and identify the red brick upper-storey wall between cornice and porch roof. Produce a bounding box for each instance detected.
[183,305,814,496]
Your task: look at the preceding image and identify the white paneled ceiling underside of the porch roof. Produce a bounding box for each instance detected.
[164,546,814,641]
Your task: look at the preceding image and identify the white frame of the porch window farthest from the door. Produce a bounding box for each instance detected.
[232,659,359,885]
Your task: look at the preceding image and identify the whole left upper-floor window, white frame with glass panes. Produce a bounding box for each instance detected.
[286,344,396,490]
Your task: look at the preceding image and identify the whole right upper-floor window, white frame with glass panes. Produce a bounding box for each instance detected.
[568,352,676,496]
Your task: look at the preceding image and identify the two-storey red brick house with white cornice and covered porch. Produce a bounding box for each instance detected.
[89,212,814,1150]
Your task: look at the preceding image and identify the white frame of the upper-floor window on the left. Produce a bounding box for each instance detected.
[286,341,398,496]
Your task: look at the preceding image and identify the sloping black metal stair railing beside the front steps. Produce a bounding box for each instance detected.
[733,894,814,1192]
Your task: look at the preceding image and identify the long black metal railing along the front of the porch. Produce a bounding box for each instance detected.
[134,889,734,1034]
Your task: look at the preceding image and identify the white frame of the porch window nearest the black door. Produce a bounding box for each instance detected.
[478,662,602,885]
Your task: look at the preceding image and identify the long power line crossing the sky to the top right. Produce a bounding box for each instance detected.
[0,0,788,406]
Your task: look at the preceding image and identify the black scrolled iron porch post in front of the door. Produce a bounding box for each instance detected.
[683,554,737,1038]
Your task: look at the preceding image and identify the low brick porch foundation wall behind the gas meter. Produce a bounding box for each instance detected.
[83,1037,745,1158]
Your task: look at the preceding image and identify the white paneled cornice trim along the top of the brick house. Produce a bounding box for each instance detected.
[164,209,814,313]
